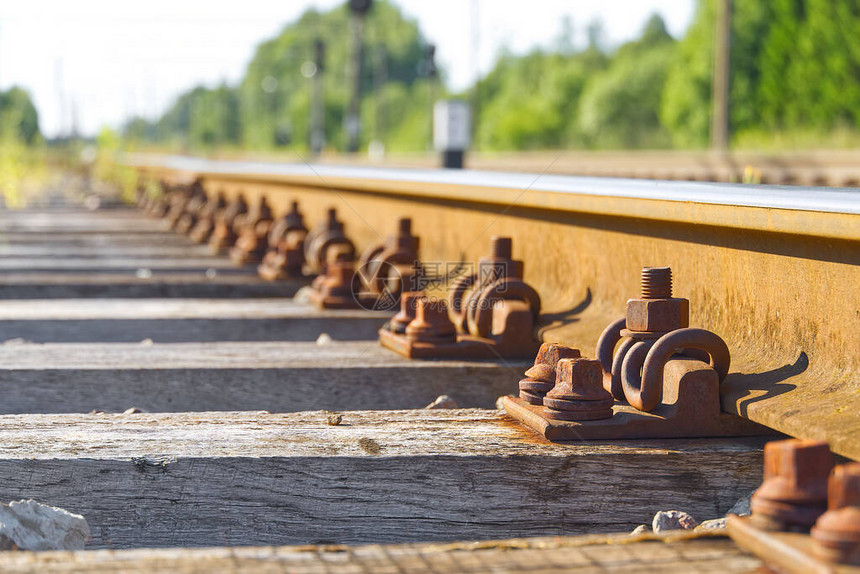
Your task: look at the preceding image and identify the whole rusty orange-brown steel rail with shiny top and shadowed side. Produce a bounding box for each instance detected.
[126,156,860,459]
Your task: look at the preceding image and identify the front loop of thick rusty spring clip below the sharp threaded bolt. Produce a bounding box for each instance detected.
[618,328,731,411]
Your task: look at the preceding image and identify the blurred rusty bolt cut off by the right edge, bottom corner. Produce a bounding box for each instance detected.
[811,462,860,565]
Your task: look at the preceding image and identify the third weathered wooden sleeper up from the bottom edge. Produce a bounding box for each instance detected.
[0,342,527,413]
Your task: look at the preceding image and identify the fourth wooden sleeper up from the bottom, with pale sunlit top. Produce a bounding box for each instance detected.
[0,299,391,343]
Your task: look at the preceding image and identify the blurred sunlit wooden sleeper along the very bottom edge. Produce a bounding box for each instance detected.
[0,536,761,574]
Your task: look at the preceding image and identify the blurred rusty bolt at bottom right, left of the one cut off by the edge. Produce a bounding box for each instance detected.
[750,439,833,531]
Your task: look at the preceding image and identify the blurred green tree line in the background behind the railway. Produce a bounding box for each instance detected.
[124,0,860,153]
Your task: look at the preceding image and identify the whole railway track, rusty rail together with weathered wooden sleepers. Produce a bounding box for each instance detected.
[0,156,860,572]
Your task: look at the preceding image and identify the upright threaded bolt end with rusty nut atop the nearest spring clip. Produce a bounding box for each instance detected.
[627,267,690,333]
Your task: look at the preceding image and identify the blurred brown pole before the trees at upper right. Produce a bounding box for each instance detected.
[711,0,732,152]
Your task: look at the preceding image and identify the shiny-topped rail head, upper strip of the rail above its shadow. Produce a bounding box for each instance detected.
[127,155,860,243]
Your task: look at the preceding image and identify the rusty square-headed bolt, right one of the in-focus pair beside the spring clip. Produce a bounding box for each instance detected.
[543,359,615,421]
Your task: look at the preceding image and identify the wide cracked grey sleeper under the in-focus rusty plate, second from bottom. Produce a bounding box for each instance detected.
[0,409,762,548]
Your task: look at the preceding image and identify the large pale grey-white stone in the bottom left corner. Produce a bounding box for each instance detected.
[0,500,90,550]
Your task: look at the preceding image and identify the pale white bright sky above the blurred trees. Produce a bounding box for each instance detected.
[0,0,694,136]
